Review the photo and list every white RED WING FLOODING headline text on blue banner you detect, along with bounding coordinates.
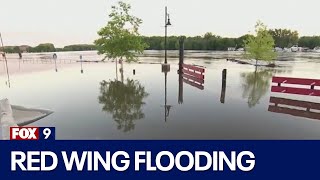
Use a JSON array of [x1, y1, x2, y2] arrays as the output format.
[[11, 151, 255, 172]]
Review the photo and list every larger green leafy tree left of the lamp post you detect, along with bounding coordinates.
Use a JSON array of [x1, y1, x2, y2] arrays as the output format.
[[94, 1, 147, 62]]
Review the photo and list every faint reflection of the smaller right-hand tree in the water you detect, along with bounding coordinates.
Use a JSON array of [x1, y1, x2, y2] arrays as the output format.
[[241, 69, 274, 108]]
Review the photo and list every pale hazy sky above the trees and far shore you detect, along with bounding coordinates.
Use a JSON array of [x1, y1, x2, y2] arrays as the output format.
[[0, 0, 320, 47]]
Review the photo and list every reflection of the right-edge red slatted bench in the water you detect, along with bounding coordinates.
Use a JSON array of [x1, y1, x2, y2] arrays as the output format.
[[268, 97, 320, 120]]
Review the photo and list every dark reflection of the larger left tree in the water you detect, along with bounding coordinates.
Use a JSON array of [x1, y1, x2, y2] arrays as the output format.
[[99, 79, 149, 132]]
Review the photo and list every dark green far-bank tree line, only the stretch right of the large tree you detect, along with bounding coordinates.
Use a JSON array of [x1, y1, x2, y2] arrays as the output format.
[[144, 29, 320, 51]]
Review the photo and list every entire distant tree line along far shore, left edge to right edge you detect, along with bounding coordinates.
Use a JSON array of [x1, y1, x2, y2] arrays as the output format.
[[0, 29, 320, 53]]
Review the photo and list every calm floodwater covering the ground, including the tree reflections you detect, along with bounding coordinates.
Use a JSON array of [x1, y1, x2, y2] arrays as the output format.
[[0, 51, 320, 140]]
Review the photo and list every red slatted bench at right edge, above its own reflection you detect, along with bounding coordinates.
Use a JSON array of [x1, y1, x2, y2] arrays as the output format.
[[271, 77, 320, 96]]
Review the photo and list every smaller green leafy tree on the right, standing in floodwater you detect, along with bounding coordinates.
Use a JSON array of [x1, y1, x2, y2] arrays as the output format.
[[245, 21, 277, 63]]
